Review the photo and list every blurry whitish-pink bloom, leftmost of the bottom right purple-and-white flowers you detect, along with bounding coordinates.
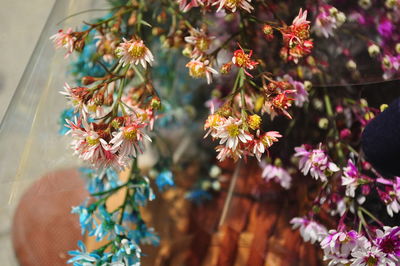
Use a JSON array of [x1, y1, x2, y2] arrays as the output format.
[[290, 217, 328, 244]]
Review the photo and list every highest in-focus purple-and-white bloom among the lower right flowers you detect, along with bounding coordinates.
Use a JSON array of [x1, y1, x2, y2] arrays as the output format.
[[294, 146, 340, 182]]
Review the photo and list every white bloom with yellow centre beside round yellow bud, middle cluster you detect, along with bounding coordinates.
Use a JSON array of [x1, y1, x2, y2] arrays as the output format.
[[212, 117, 253, 150]]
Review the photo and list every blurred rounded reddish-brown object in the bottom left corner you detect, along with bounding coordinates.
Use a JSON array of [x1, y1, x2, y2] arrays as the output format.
[[12, 169, 87, 266]]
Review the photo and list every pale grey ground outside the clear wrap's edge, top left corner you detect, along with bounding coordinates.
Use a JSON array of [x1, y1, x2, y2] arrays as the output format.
[[0, 0, 55, 121]]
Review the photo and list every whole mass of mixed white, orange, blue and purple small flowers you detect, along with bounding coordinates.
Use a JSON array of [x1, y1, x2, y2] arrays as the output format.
[[51, 0, 400, 265]]
